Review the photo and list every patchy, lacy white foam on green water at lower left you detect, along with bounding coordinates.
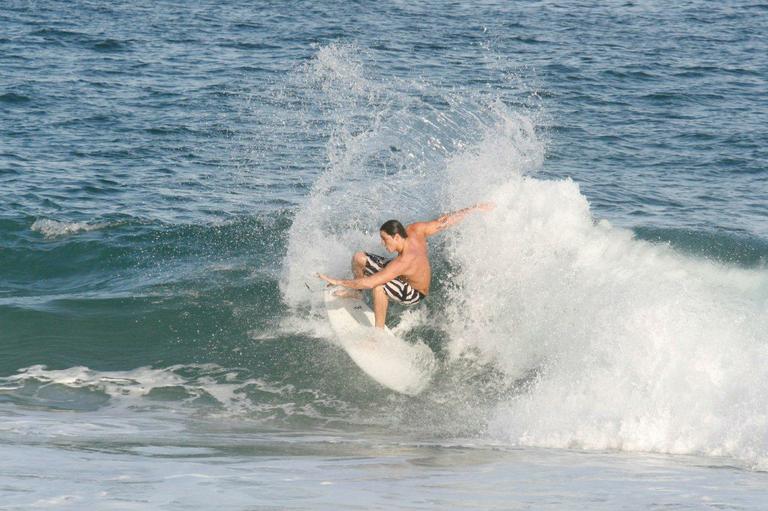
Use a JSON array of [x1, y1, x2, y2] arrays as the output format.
[[0, 364, 358, 437]]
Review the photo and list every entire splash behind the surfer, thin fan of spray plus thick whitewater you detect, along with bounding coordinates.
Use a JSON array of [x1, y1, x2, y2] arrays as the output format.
[[281, 46, 768, 466]]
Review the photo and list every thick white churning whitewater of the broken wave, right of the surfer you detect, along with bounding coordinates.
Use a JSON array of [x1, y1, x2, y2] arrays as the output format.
[[440, 124, 768, 465]]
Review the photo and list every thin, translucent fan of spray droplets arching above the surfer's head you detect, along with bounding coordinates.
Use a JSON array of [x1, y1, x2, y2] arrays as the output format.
[[281, 45, 544, 307]]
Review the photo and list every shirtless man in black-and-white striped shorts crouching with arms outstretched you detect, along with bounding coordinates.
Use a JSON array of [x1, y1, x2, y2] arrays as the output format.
[[317, 202, 496, 328]]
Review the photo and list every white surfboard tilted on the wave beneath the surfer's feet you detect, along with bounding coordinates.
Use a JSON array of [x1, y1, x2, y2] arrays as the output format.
[[325, 288, 436, 396]]
